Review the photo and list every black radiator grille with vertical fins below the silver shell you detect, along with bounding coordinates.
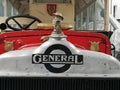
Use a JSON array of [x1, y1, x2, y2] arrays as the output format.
[[0, 77, 120, 90]]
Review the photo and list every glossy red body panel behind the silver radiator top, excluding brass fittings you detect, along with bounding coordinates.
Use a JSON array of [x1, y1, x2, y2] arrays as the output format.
[[0, 30, 111, 54]]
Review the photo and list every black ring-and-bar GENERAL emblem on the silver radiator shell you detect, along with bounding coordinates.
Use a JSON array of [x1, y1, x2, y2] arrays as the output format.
[[32, 44, 83, 73]]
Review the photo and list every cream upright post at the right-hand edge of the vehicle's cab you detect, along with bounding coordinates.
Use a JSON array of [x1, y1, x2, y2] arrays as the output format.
[[104, 0, 109, 31]]
